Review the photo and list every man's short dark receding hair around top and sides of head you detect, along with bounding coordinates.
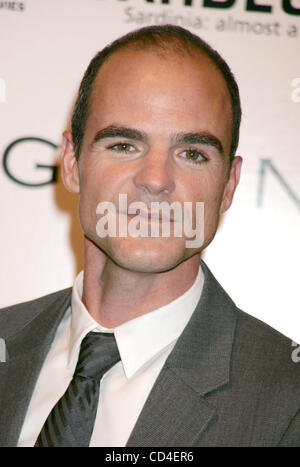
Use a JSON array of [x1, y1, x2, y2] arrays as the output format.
[[72, 24, 241, 165]]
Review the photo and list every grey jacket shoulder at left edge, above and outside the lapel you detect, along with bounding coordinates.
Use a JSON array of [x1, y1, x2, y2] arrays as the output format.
[[0, 287, 72, 337]]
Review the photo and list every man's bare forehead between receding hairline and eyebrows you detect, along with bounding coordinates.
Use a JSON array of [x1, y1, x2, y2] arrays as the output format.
[[86, 47, 232, 156]]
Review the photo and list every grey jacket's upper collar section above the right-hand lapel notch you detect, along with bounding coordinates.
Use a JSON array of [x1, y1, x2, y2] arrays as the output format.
[[166, 261, 237, 395]]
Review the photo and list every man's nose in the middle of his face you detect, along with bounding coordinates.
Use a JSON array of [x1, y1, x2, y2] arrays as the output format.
[[133, 150, 175, 197]]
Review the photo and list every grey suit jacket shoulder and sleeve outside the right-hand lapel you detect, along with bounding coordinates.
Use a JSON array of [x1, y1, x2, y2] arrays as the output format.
[[207, 300, 300, 446]]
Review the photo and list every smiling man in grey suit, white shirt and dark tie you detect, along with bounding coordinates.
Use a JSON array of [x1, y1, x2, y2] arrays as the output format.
[[0, 26, 300, 447]]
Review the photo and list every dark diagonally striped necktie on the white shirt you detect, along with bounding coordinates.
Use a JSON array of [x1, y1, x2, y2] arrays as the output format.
[[35, 332, 120, 447]]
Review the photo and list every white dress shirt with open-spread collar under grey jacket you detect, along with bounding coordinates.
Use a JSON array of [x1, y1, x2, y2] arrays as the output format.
[[18, 267, 203, 447]]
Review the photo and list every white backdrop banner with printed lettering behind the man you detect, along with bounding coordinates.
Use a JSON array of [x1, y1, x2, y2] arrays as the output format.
[[0, 0, 300, 342]]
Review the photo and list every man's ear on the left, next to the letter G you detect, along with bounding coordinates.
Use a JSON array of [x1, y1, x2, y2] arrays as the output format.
[[61, 131, 80, 193]]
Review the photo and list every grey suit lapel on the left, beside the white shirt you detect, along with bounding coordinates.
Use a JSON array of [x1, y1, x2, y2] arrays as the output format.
[[0, 290, 71, 446]]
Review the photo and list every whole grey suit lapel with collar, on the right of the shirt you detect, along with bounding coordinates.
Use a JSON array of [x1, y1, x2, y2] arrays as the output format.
[[127, 261, 237, 447]]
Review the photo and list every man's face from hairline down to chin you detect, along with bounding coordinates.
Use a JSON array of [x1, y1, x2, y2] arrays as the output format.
[[62, 48, 241, 272]]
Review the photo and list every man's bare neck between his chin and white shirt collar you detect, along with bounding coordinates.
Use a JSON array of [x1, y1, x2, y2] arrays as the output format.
[[82, 237, 200, 328]]
